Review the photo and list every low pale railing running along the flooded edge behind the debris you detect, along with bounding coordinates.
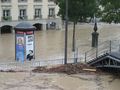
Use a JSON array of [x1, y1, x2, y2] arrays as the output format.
[[0, 58, 80, 71]]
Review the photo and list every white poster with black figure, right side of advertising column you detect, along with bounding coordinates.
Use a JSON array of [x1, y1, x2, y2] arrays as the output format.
[[26, 34, 34, 61]]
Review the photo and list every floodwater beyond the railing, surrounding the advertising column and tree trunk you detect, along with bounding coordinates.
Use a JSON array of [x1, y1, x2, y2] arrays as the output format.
[[0, 23, 120, 62]]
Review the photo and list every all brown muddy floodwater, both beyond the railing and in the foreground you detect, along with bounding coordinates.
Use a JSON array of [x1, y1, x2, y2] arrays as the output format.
[[0, 23, 120, 90]]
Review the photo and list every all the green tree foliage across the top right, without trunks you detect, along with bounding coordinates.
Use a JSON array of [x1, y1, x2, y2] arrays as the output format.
[[55, 0, 120, 23]]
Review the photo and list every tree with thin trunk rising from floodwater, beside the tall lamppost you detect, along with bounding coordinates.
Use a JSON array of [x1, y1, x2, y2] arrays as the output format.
[[55, 0, 98, 51]]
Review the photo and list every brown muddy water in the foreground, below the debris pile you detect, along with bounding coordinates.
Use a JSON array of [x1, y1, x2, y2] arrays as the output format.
[[0, 72, 120, 90]]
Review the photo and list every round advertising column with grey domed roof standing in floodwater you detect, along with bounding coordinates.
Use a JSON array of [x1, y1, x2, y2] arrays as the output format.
[[14, 22, 35, 62]]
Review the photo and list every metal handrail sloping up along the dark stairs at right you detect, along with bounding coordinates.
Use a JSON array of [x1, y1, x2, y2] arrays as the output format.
[[85, 40, 120, 62]]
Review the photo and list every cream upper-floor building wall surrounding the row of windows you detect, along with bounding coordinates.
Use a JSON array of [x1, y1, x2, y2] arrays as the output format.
[[0, 0, 59, 21]]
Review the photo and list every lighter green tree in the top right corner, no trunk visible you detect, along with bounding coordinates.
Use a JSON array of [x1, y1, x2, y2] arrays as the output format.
[[99, 0, 120, 23]]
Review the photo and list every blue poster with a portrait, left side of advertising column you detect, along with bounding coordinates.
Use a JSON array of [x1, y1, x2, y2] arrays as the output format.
[[16, 34, 24, 62]]
